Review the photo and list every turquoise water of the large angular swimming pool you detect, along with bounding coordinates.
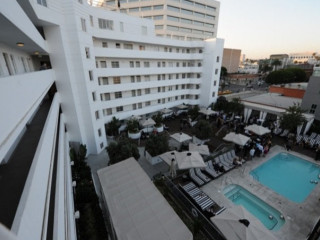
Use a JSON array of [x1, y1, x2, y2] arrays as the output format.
[[250, 153, 320, 203]]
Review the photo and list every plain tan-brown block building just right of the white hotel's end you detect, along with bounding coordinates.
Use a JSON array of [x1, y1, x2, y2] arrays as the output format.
[[222, 48, 241, 73]]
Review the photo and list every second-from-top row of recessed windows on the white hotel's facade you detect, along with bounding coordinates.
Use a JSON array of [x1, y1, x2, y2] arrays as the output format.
[[96, 60, 202, 68]]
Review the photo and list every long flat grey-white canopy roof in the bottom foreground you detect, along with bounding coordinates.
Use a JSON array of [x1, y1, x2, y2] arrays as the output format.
[[98, 158, 193, 240]]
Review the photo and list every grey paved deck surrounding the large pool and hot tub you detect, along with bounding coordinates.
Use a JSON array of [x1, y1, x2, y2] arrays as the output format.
[[201, 146, 320, 240]]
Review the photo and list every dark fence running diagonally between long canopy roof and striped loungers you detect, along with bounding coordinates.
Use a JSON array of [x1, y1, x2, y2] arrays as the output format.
[[164, 176, 226, 240]]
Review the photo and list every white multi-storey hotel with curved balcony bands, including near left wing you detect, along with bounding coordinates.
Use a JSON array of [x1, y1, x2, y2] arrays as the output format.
[[0, 0, 224, 236]]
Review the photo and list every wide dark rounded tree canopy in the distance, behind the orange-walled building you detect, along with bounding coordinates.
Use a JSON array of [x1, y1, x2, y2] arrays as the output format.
[[266, 68, 307, 84]]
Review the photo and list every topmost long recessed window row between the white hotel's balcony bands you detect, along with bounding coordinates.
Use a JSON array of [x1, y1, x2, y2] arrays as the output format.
[[96, 41, 202, 56]]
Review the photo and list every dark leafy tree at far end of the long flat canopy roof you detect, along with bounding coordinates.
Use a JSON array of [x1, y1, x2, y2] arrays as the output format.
[[107, 139, 140, 164]]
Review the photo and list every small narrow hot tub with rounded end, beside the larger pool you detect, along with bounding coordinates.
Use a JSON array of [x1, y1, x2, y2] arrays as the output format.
[[223, 184, 285, 231]]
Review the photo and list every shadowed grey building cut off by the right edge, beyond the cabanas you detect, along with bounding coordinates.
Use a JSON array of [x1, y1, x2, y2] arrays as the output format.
[[301, 67, 320, 120]]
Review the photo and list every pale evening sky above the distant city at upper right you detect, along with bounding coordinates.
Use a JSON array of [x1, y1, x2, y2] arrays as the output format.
[[217, 0, 320, 59]]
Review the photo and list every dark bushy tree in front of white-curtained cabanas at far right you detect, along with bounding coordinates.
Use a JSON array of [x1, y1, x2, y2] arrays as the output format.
[[280, 105, 306, 133]]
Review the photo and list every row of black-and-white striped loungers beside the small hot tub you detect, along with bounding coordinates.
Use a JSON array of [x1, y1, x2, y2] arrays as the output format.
[[180, 182, 221, 212]]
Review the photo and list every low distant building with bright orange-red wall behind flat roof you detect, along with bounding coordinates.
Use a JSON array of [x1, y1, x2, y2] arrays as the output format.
[[269, 82, 308, 99]]
